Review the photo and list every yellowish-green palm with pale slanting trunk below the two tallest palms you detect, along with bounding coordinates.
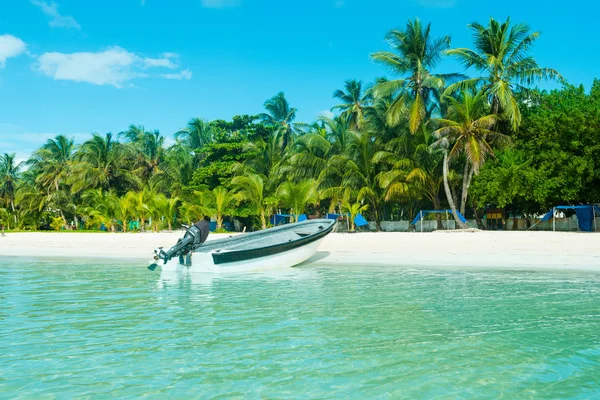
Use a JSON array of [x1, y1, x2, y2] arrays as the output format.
[[434, 91, 509, 222]]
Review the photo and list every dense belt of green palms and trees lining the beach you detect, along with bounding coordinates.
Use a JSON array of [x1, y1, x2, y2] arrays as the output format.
[[0, 18, 600, 232]]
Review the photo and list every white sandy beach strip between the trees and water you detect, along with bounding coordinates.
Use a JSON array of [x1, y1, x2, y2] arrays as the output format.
[[0, 232, 600, 272]]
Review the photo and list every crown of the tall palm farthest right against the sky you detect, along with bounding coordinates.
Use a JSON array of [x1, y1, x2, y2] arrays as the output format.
[[446, 17, 561, 130]]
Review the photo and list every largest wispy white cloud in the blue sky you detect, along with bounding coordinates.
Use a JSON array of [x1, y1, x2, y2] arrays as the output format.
[[35, 46, 192, 88]]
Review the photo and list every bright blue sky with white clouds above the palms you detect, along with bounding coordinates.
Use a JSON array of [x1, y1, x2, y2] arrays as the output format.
[[0, 0, 600, 160]]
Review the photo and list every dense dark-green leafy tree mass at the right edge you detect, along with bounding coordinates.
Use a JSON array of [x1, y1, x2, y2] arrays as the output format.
[[472, 81, 600, 212]]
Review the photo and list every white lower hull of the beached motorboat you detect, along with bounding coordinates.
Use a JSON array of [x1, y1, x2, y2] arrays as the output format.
[[161, 238, 323, 273]]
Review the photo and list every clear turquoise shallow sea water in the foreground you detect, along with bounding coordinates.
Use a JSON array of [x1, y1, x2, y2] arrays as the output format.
[[0, 259, 600, 399]]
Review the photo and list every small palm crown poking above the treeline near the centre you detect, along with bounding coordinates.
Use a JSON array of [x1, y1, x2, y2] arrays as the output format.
[[259, 92, 299, 153]]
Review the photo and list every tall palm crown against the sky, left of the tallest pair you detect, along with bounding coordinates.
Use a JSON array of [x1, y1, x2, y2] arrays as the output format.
[[371, 19, 462, 134]]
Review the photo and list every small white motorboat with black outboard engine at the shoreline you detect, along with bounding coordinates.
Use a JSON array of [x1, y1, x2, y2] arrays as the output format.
[[148, 219, 335, 272]]
